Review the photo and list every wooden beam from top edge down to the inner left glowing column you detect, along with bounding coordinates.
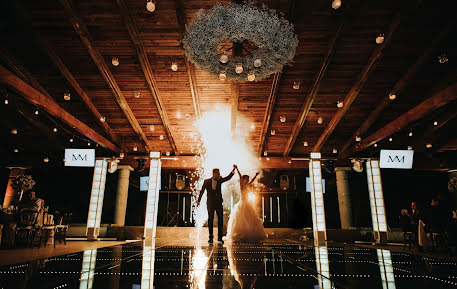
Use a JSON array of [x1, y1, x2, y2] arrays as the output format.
[[60, 0, 153, 150]]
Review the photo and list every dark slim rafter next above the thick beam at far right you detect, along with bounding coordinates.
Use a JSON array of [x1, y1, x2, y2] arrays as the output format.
[[340, 23, 455, 157]]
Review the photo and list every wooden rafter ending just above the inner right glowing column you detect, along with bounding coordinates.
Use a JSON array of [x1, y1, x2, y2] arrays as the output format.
[[313, 15, 400, 151]]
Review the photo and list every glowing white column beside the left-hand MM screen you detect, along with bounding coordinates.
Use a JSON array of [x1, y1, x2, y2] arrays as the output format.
[[86, 158, 108, 240]]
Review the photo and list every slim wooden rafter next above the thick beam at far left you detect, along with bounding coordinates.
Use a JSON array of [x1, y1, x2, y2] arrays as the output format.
[[35, 35, 120, 144]]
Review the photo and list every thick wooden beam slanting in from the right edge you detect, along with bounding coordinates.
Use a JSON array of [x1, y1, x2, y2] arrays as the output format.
[[351, 83, 457, 153]]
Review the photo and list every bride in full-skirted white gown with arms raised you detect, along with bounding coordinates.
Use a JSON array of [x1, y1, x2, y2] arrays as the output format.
[[227, 168, 265, 242]]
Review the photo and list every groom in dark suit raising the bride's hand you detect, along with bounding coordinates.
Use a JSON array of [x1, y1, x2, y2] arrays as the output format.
[[197, 165, 237, 243]]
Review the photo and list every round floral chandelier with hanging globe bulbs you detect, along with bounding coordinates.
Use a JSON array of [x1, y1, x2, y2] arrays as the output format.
[[183, 2, 298, 82]]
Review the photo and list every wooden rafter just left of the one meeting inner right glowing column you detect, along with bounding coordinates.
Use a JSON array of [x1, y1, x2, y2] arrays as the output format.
[[283, 21, 344, 156]]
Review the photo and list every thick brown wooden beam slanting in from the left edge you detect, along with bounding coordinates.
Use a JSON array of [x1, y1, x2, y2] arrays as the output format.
[[0, 66, 121, 153]]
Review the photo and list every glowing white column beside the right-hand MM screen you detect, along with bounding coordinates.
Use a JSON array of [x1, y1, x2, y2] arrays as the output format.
[[366, 159, 388, 243]]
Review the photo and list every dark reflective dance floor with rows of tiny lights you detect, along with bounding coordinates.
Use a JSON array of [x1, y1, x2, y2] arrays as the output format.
[[0, 241, 457, 289]]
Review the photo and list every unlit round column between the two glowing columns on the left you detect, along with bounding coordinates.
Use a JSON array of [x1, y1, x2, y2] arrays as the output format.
[[113, 165, 133, 227]]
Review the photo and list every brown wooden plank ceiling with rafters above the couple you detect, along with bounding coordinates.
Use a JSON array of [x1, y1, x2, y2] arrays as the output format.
[[0, 0, 457, 169]]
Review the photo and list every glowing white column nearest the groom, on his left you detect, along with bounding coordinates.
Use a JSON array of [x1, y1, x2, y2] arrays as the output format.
[[144, 152, 161, 238]]
